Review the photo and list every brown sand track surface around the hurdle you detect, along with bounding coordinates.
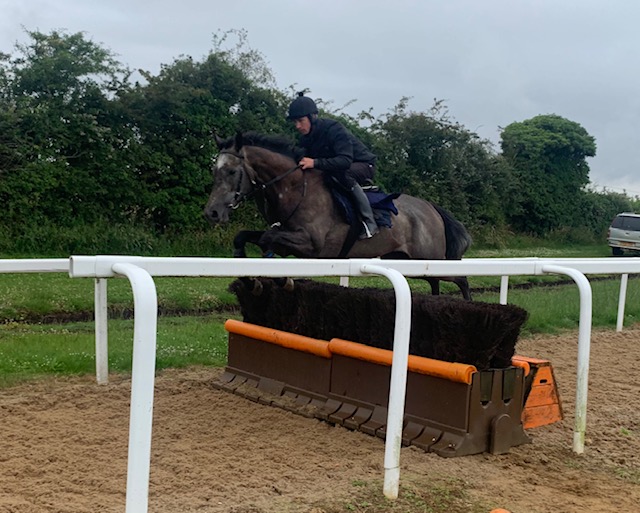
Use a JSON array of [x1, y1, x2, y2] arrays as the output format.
[[0, 326, 640, 513]]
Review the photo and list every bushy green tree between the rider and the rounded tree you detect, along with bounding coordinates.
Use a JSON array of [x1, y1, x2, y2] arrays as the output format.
[[372, 98, 509, 228]]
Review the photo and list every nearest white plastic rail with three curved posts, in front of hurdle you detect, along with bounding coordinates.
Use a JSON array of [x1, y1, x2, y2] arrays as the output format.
[[69, 256, 616, 513]]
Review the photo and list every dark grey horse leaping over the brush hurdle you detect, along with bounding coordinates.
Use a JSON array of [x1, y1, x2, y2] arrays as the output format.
[[204, 132, 471, 300]]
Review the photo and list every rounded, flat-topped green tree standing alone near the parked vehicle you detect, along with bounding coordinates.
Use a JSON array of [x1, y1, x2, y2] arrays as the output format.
[[501, 115, 596, 235]]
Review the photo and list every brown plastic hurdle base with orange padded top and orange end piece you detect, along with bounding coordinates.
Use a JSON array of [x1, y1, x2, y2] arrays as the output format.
[[216, 320, 562, 457]]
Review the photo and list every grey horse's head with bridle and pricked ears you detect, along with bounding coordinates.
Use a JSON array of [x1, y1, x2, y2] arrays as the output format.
[[204, 135, 252, 225]]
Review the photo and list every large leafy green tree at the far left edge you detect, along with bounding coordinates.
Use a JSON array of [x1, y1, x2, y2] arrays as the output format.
[[0, 31, 131, 226]]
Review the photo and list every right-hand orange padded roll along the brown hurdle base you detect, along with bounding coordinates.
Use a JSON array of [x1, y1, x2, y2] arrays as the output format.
[[329, 338, 477, 385]]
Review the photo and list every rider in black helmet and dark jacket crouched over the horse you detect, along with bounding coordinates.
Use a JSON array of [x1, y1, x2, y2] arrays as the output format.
[[287, 93, 378, 239]]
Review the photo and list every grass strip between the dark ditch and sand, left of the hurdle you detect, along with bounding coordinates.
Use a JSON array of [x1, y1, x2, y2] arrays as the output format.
[[0, 313, 235, 387]]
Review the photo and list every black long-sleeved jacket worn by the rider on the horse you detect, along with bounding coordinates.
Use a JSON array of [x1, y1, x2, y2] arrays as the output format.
[[299, 118, 376, 171]]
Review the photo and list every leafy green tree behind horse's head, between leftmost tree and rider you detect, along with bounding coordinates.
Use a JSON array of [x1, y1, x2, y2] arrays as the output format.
[[122, 45, 284, 230]]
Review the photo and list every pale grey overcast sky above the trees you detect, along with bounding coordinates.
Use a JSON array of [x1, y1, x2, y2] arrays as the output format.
[[5, 0, 640, 196]]
